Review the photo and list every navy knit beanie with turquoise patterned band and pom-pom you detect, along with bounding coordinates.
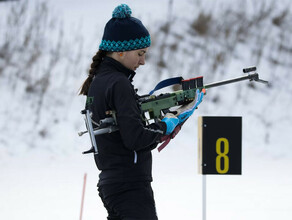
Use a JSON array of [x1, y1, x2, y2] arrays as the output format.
[[99, 4, 151, 52]]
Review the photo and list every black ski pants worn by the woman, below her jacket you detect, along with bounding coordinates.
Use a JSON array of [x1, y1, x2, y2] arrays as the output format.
[[98, 182, 158, 220]]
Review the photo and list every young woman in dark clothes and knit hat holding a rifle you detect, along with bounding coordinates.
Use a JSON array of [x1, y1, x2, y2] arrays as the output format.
[[80, 4, 203, 220]]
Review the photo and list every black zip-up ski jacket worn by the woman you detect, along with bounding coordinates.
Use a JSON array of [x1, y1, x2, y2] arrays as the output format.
[[88, 57, 166, 186]]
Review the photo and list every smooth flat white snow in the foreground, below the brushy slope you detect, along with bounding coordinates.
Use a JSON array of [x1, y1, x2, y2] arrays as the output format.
[[0, 131, 292, 220]]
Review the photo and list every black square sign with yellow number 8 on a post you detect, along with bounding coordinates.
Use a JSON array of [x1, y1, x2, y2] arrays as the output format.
[[198, 116, 242, 175]]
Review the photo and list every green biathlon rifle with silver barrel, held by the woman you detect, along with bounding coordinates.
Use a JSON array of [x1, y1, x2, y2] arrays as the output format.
[[78, 67, 268, 154]]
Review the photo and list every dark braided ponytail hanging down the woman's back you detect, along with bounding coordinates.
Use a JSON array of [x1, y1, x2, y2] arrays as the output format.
[[79, 50, 106, 96]]
